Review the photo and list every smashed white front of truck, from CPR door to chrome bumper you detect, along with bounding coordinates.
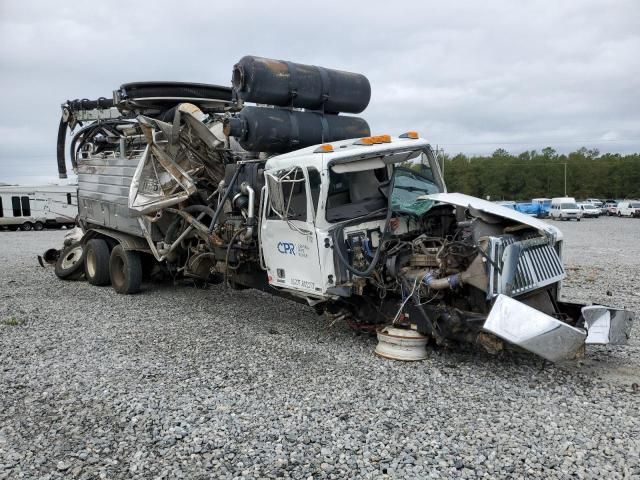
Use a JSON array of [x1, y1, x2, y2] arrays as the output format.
[[261, 134, 632, 361]]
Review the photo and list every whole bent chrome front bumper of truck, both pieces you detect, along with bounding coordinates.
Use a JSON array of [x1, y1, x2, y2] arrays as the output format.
[[483, 295, 635, 362]]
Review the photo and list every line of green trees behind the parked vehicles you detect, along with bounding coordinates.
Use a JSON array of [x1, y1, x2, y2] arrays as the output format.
[[438, 147, 640, 200]]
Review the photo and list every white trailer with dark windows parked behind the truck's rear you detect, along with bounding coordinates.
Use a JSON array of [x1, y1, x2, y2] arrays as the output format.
[[0, 185, 78, 230]]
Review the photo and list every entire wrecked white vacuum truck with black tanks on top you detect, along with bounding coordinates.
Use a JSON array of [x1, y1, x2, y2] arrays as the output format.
[[56, 57, 633, 361]]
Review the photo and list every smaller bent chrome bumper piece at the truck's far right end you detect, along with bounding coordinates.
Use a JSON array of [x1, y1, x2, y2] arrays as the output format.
[[582, 305, 634, 345]]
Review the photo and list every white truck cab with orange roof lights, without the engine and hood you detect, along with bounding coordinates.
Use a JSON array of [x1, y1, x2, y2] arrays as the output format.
[[260, 132, 446, 297]]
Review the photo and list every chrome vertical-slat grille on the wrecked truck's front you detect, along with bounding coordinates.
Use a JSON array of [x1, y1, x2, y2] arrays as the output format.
[[489, 235, 565, 297]]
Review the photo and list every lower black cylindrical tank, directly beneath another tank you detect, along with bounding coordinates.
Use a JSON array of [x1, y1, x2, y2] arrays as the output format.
[[225, 107, 371, 153]]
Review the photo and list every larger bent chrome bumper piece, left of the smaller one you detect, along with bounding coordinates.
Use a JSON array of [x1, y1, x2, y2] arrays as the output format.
[[483, 295, 587, 362]]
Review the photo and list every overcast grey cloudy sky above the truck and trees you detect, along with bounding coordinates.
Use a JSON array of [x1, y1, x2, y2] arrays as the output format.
[[0, 0, 640, 184]]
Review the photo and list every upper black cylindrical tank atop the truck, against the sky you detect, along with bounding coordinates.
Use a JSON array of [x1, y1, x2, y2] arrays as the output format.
[[231, 56, 371, 113]]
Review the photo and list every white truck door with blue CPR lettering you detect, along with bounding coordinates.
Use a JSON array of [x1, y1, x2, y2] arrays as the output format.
[[260, 167, 322, 295]]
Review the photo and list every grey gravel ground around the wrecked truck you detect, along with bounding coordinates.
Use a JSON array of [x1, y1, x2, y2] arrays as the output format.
[[0, 218, 640, 479]]
